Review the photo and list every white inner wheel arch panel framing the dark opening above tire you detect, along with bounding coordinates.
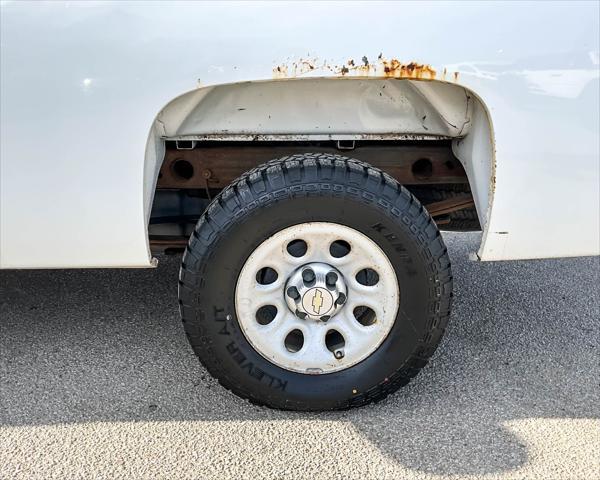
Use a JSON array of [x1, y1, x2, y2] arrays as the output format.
[[144, 75, 495, 262]]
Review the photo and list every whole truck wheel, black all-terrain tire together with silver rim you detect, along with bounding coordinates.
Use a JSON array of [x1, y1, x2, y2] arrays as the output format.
[[179, 154, 452, 410]]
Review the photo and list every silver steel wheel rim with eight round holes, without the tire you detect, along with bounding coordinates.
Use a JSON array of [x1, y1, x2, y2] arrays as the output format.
[[235, 222, 399, 374]]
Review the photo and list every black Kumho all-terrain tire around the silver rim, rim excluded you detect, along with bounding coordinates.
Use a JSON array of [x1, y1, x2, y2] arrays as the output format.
[[179, 154, 452, 410]]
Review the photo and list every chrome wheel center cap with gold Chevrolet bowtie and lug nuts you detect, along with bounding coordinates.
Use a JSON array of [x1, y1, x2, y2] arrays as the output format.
[[284, 262, 348, 322]]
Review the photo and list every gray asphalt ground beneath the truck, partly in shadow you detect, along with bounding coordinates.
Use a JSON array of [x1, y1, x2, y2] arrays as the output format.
[[0, 234, 600, 480]]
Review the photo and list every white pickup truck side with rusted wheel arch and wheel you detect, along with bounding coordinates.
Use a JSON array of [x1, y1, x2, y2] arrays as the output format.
[[0, 1, 600, 410]]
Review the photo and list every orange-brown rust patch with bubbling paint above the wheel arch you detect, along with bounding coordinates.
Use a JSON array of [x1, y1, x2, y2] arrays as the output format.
[[273, 54, 458, 81]]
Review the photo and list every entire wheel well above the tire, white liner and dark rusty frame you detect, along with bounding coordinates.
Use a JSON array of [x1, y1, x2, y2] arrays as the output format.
[[144, 78, 494, 255]]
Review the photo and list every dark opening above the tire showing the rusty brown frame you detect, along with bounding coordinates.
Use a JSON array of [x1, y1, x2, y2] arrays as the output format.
[[149, 140, 481, 253]]
